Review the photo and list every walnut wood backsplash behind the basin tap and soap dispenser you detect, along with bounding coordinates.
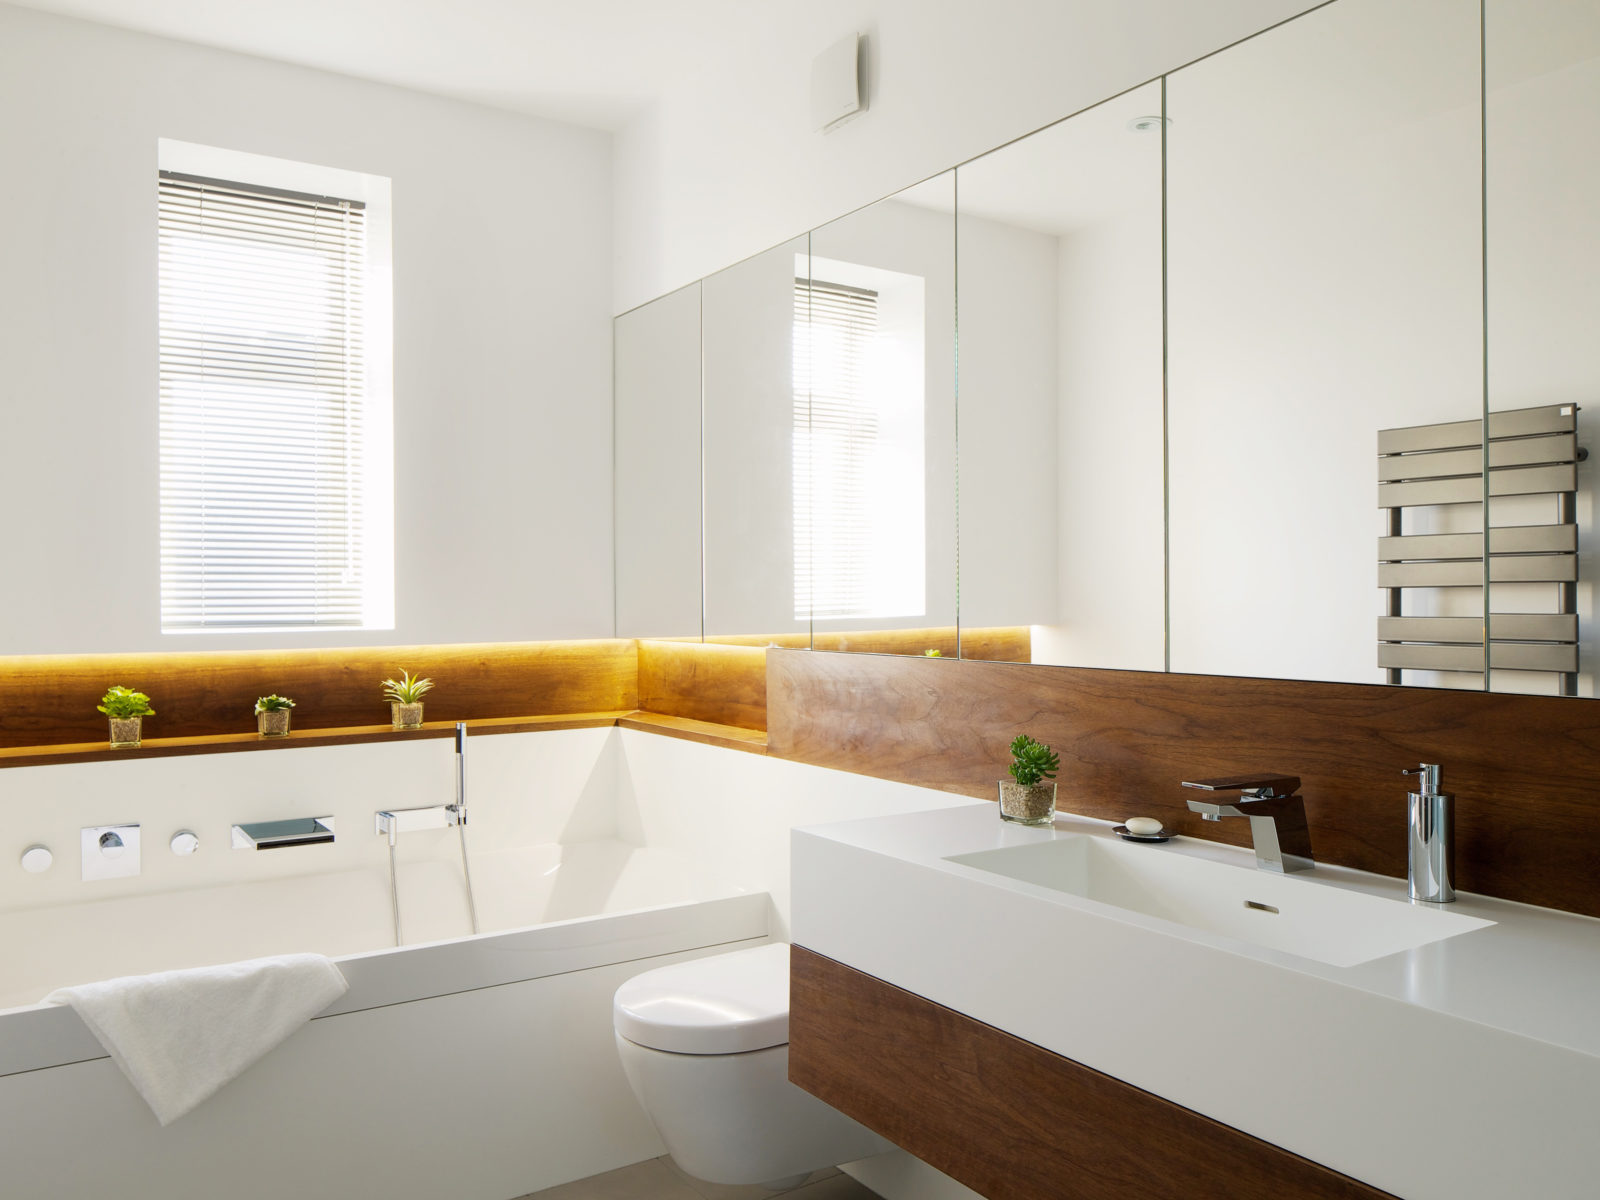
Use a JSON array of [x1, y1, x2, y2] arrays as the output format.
[[768, 650, 1600, 917]]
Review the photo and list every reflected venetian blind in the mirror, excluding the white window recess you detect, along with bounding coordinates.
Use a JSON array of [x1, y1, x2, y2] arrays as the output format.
[[794, 278, 878, 621]]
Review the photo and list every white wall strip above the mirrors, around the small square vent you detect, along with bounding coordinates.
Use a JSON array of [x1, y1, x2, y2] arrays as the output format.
[[614, 0, 1312, 312]]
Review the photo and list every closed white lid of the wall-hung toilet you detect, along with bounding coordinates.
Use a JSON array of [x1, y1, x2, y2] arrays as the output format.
[[611, 942, 789, 1054]]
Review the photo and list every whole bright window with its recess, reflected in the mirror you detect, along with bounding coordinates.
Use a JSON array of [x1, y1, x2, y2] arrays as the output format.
[[794, 256, 928, 621]]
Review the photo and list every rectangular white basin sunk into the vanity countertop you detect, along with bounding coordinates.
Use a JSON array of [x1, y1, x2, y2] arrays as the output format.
[[946, 834, 1494, 966]]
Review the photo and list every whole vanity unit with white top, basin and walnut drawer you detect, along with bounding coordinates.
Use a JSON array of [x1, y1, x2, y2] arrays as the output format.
[[790, 803, 1600, 1200]]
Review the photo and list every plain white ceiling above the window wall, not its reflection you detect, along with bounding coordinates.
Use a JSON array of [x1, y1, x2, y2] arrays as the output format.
[[11, 0, 773, 130]]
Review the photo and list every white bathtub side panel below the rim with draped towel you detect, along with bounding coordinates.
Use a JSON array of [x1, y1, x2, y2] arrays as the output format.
[[0, 954, 758, 1200]]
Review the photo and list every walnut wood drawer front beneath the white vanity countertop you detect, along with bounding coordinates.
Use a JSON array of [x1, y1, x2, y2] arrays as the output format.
[[789, 946, 1389, 1200]]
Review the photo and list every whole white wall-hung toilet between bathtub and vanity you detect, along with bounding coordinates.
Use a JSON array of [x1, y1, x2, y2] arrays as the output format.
[[611, 944, 894, 1184]]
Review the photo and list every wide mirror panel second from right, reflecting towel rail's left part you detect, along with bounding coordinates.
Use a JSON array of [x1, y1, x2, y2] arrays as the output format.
[[1166, 0, 1485, 688]]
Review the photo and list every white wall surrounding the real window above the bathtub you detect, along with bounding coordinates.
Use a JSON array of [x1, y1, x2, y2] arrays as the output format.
[[0, 5, 613, 654]]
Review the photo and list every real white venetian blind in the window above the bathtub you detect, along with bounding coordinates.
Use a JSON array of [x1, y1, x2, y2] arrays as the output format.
[[160, 171, 366, 632]]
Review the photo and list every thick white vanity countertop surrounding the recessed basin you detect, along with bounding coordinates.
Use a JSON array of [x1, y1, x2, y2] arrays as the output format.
[[794, 802, 1600, 1200]]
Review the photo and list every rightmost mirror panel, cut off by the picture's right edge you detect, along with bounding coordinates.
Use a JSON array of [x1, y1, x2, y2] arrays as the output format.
[[1485, 0, 1600, 696]]
